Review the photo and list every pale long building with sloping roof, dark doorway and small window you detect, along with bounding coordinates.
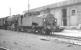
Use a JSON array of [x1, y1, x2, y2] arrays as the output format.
[[23, 0, 81, 27]]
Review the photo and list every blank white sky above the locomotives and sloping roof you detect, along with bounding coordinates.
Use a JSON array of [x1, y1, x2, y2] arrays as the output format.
[[0, 0, 64, 18]]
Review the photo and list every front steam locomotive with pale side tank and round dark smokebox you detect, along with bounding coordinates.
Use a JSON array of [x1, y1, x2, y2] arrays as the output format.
[[17, 13, 63, 34]]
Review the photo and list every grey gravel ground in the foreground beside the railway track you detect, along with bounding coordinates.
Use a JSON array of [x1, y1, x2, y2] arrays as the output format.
[[0, 30, 81, 50]]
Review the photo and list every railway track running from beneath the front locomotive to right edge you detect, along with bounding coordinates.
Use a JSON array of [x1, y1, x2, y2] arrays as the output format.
[[38, 34, 81, 46]]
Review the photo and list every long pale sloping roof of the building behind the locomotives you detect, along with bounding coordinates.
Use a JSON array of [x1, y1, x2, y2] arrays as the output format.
[[30, 0, 81, 11]]
